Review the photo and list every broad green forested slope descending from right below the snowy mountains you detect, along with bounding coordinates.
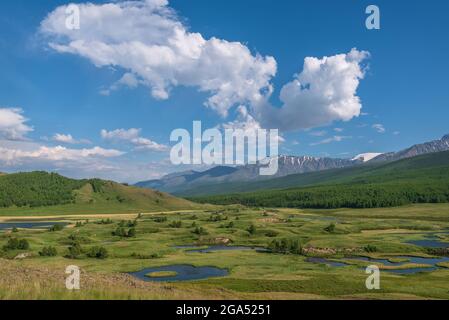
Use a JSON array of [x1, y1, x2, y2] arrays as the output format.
[[192, 152, 449, 208]]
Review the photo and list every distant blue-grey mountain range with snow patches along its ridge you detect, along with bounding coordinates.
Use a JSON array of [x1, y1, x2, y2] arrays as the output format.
[[136, 135, 449, 196]]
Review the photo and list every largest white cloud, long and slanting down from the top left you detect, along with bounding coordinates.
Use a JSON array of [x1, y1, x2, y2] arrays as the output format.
[[40, 0, 277, 116]]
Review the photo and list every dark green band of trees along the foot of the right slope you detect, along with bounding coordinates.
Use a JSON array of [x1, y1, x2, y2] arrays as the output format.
[[190, 182, 449, 209]]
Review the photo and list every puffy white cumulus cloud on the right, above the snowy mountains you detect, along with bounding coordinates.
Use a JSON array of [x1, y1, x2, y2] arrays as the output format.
[[255, 49, 369, 131]]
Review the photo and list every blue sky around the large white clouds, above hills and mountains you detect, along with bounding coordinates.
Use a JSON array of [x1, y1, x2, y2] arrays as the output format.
[[0, 0, 449, 182]]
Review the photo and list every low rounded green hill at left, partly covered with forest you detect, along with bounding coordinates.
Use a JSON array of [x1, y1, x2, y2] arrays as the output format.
[[0, 172, 198, 215]]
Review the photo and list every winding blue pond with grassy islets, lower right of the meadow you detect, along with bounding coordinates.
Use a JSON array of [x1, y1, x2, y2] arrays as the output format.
[[306, 256, 449, 274]]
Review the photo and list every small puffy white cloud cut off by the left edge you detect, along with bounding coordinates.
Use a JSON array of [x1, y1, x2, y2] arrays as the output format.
[[0, 108, 33, 140]]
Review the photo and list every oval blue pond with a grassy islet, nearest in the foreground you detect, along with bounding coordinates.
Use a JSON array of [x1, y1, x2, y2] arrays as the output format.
[[129, 265, 229, 282]]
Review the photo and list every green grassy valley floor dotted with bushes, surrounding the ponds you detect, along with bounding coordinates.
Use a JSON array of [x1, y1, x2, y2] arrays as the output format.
[[0, 204, 449, 299]]
